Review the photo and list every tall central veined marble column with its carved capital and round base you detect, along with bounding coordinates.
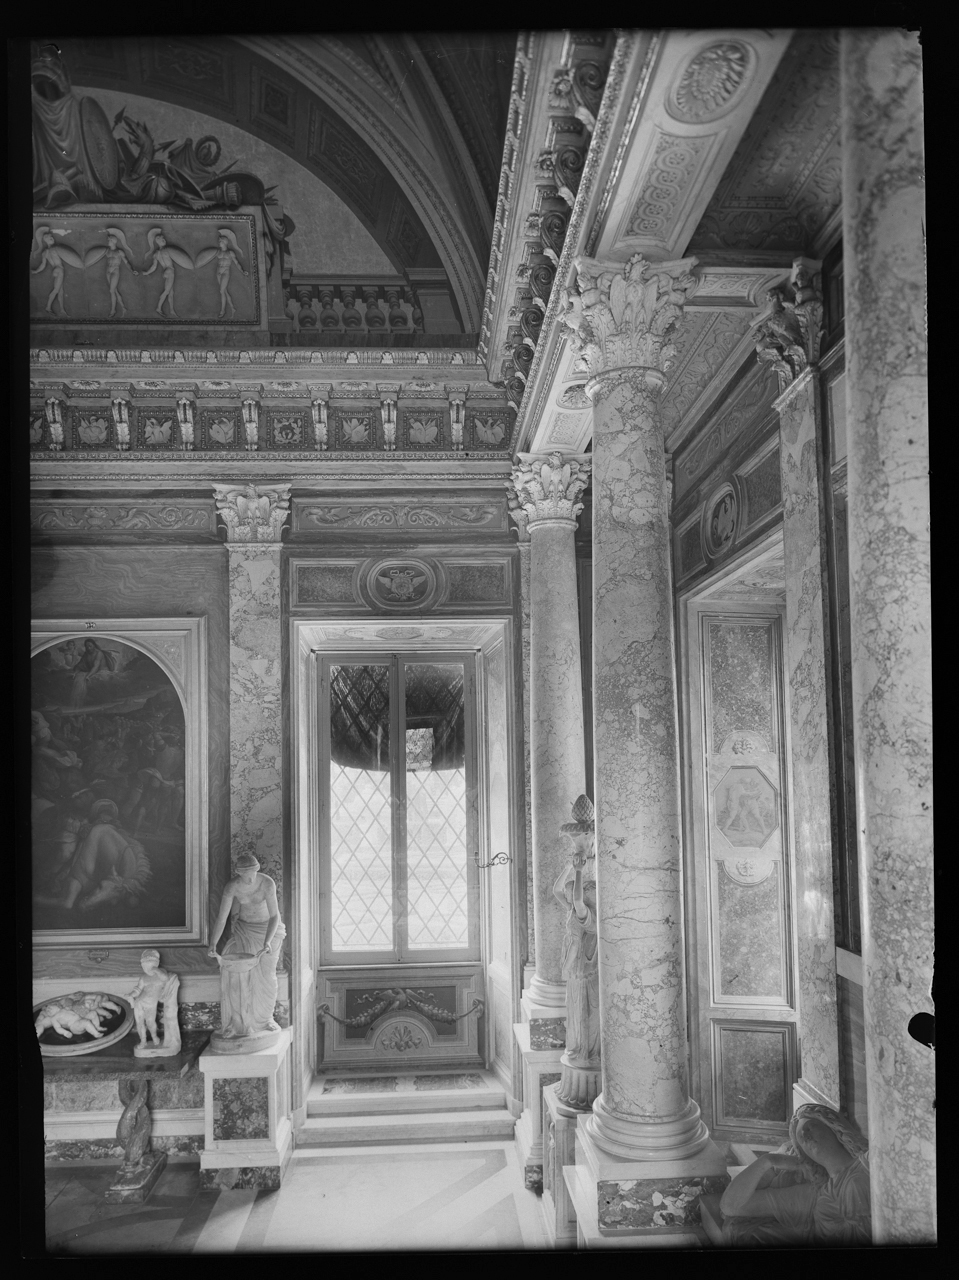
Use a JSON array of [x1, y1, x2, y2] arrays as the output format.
[[565, 255, 726, 1243]]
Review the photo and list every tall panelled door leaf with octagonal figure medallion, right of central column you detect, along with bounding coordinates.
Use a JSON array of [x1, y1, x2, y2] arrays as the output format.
[[684, 603, 798, 1143]]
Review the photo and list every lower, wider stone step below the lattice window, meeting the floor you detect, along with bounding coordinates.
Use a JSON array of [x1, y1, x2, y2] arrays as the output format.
[[296, 1108, 516, 1149]]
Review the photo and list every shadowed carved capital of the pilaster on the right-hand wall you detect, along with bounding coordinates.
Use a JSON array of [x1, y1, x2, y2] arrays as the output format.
[[753, 257, 822, 396]]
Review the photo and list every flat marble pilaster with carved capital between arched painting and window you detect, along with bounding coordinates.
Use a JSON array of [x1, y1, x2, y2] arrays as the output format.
[[214, 484, 289, 914]]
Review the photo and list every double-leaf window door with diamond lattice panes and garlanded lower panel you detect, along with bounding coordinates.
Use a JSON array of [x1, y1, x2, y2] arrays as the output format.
[[318, 653, 483, 1070]]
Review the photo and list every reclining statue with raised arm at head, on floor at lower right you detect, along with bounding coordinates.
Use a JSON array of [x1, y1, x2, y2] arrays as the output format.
[[720, 1103, 872, 1245]]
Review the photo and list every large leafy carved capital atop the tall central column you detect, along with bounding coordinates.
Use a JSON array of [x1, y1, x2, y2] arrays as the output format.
[[562, 253, 697, 376]]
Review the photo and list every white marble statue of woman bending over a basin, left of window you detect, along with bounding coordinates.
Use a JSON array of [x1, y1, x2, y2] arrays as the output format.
[[209, 854, 287, 1052]]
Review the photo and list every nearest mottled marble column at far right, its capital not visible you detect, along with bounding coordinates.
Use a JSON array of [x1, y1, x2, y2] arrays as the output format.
[[841, 29, 936, 1245]]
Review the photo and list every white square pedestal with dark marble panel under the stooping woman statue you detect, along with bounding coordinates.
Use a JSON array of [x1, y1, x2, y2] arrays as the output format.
[[200, 1028, 293, 1190]]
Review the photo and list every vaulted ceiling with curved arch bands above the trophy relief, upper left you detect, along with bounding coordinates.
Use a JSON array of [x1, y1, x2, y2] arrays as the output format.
[[46, 32, 516, 332]]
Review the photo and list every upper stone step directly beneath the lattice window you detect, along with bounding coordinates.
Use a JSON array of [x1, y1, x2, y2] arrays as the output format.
[[306, 1071, 506, 1116]]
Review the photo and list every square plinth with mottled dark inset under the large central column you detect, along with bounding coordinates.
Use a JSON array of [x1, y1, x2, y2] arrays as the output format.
[[565, 1116, 730, 1248]]
